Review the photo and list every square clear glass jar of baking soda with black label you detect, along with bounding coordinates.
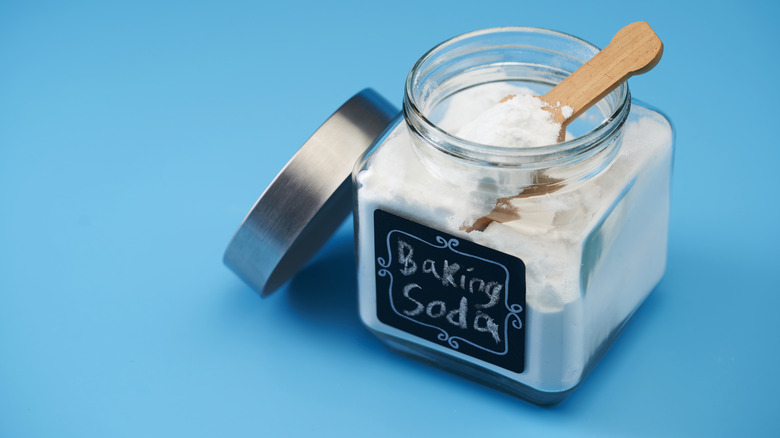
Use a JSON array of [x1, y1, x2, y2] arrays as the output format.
[[353, 27, 673, 404]]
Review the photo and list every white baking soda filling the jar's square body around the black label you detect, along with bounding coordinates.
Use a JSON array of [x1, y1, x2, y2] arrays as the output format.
[[356, 84, 671, 392]]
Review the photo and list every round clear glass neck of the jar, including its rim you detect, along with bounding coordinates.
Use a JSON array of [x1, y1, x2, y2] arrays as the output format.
[[403, 27, 630, 192]]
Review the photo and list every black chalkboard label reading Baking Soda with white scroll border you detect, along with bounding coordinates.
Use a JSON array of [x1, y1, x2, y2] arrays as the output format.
[[374, 210, 525, 373]]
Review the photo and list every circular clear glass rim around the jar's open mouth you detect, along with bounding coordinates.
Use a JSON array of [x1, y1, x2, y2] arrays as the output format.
[[403, 26, 631, 165]]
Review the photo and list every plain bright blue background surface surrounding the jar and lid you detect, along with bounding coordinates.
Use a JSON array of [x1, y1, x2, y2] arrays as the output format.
[[0, 0, 780, 437]]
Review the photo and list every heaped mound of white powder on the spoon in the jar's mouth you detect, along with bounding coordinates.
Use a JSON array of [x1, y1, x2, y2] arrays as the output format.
[[456, 94, 561, 147]]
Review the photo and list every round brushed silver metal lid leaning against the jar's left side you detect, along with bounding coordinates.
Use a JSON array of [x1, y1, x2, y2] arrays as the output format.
[[223, 89, 398, 296]]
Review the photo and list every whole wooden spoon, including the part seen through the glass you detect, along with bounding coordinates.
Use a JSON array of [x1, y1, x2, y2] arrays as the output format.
[[462, 21, 664, 232]]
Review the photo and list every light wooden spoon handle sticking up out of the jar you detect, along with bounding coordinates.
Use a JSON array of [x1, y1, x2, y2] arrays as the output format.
[[541, 21, 664, 128]]
